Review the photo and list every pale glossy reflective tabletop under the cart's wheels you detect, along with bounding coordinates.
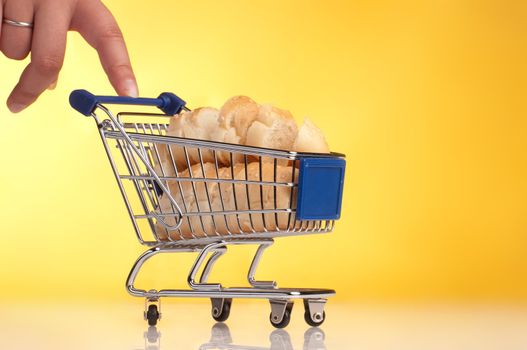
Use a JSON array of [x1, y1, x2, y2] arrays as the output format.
[[0, 299, 527, 350]]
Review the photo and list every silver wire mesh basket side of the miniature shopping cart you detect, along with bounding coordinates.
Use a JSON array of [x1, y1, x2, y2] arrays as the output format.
[[101, 119, 334, 243]]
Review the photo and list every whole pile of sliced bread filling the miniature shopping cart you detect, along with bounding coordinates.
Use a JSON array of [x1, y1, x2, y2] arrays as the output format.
[[154, 96, 329, 241]]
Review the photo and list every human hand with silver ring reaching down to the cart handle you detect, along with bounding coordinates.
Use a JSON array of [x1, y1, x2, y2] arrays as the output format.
[[0, 0, 138, 113]]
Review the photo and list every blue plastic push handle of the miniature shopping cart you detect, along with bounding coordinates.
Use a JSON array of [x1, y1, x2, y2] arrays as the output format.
[[70, 90, 186, 116]]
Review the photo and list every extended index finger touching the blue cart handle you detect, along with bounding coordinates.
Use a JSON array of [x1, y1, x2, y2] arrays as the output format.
[[72, 0, 138, 97]]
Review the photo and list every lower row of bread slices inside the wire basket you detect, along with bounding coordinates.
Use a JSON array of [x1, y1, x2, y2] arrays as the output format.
[[155, 162, 296, 240]]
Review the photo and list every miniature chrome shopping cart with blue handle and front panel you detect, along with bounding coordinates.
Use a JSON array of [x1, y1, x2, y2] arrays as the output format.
[[70, 90, 345, 328]]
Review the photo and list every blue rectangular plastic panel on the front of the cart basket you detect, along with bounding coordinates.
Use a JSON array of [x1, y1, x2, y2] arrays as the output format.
[[296, 157, 346, 220]]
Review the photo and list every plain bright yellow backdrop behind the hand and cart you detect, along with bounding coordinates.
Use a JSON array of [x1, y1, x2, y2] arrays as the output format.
[[0, 0, 527, 301]]
